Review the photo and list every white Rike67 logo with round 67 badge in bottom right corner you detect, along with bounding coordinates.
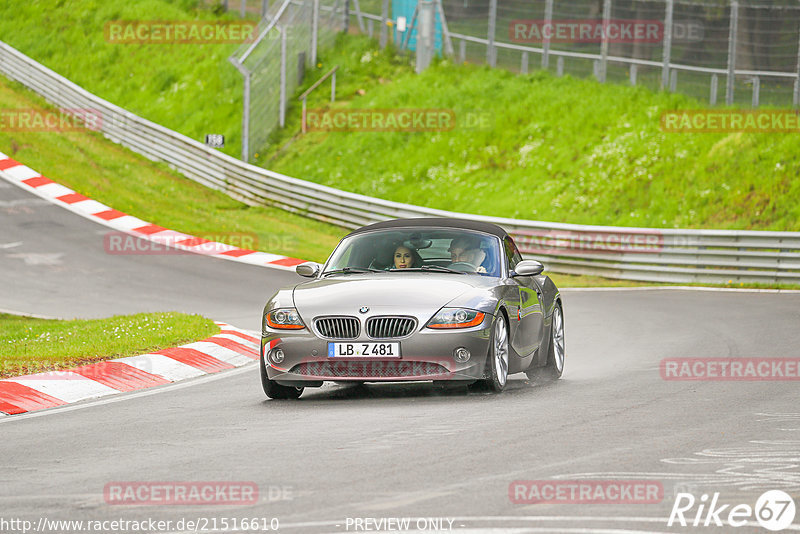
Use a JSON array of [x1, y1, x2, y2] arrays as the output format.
[[667, 490, 795, 531]]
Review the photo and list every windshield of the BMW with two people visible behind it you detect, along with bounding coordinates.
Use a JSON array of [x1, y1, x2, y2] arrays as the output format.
[[323, 227, 501, 276]]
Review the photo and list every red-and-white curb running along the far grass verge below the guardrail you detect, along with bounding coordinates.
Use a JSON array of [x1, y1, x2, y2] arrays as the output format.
[[0, 152, 305, 270]]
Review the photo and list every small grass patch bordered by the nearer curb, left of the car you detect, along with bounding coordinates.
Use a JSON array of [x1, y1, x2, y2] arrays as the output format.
[[0, 313, 219, 378]]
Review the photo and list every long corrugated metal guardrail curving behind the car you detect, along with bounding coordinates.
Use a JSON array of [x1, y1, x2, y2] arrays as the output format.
[[0, 38, 800, 284]]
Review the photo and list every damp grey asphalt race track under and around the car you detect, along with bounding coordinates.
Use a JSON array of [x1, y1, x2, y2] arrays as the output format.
[[0, 182, 800, 532]]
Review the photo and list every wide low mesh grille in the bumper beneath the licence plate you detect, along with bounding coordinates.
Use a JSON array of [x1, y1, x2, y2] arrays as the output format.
[[290, 360, 449, 379]]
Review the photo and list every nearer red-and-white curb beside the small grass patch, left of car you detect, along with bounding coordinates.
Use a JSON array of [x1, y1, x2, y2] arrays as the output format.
[[0, 322, 261, 416]]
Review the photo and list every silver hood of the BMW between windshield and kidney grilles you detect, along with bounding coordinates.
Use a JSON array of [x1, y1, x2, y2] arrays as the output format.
[[294, 273, 496, 321]]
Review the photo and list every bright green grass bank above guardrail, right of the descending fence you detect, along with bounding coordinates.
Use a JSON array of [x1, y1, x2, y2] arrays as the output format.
[[259, 36, 800, 230]]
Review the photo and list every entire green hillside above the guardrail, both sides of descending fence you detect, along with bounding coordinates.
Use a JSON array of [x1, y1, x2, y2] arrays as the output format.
[[0, 0, 800, 230]]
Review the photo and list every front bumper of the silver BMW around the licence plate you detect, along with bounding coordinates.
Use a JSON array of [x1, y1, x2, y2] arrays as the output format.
[[261, 320, 493, 385]]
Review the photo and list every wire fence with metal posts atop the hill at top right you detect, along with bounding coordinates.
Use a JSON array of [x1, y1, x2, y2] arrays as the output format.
[[352, 0, 800, 107]]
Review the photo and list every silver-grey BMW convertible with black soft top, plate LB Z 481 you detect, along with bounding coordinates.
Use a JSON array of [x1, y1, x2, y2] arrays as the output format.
[[261, 218, 565, 399]]
